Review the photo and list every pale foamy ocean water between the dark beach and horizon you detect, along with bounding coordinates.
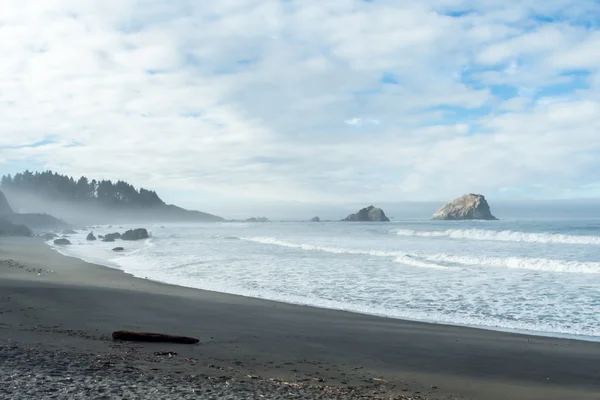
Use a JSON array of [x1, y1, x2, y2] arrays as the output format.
[[49, 219, 600, 340]]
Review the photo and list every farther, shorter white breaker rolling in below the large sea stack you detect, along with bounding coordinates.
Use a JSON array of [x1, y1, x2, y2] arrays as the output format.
[[394, 229, 600, 245]]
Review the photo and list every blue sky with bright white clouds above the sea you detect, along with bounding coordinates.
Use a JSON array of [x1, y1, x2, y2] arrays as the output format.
[[0, 0, 600, 215]]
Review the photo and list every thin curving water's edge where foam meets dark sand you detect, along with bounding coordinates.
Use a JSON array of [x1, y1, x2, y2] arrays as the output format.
[[43, 236, 600, 343]]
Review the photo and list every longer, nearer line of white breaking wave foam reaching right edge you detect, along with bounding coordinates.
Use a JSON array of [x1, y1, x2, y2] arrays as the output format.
[[240, 236, 600, 274]]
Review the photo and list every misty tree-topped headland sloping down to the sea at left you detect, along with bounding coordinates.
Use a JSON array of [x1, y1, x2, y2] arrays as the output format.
[[1, 171, 224, 224]]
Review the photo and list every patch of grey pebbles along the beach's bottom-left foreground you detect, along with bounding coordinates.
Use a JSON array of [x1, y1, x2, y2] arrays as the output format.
[[0, 345, 421, 400]]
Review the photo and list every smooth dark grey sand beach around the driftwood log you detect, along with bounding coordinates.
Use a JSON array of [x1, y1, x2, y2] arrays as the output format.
[[0, 238, 600, 400]]
